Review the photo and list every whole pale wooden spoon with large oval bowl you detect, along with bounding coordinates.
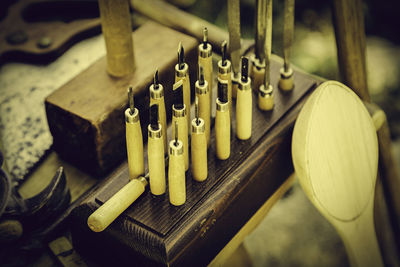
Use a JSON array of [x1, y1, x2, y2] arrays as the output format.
[[292, 81, 383, 266]]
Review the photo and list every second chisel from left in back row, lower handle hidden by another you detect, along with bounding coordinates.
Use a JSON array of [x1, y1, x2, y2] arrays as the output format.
[[149, 70, 168, 153]]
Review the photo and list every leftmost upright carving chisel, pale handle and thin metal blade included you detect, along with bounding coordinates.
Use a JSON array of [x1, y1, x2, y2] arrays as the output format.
[[125, 87, 144, 180]]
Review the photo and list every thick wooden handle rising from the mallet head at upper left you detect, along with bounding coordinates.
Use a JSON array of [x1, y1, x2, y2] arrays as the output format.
[[99, 0, 135, 77]]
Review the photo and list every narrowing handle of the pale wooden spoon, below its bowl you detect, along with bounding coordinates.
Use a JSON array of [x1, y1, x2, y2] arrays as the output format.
[[331, 197, 383, 267]]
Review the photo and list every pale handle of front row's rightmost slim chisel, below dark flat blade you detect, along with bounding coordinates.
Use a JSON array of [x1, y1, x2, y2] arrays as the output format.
[[236, 89, 253, 140]]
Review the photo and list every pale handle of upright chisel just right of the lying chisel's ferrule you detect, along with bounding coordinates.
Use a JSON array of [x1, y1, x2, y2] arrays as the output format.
[[147, 129, 166, 195]]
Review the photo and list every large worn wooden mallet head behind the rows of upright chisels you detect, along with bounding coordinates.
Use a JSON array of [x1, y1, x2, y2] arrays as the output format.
[[45, 22, 198, 176]]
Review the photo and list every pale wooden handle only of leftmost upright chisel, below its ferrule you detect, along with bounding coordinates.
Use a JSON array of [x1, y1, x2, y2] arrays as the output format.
[[125, 117, 144, 180]]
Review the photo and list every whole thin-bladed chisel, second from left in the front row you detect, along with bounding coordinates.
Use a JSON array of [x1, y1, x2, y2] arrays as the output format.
[[191, 96, 208, 182]]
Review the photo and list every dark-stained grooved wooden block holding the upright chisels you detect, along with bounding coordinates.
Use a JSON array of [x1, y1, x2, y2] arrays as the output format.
[[71, 59, 318, 266]]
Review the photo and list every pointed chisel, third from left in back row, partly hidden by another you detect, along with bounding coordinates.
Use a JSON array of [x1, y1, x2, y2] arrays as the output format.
[[175, 43, 190, 134]]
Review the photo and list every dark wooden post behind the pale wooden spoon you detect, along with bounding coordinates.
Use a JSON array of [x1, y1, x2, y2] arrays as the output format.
[[333, 0, 400, 254]]
